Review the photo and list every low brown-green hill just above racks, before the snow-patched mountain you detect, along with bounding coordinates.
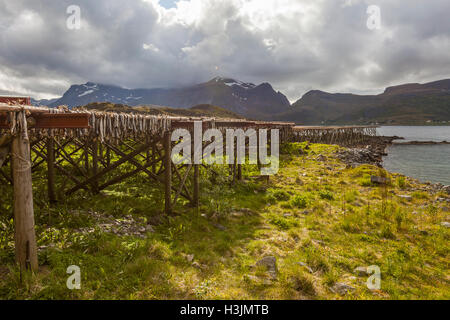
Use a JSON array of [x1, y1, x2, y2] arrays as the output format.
[[76, 102, 242, 119]]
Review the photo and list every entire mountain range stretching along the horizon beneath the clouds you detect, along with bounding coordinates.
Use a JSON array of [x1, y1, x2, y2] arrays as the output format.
[[33, 77, 450, 124]]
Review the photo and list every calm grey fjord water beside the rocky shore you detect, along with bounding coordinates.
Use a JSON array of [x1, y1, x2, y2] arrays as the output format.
[[377, 126, 450, 185]]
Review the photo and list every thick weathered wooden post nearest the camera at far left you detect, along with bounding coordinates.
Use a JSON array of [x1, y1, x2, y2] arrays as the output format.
[[11, 113, 38, 271]]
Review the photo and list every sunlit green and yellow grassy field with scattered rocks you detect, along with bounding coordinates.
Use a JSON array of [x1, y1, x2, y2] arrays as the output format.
[[0, 144, 450, 299]]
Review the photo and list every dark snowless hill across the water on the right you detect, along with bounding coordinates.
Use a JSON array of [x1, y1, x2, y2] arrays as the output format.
[[274, 79, 450, 124]]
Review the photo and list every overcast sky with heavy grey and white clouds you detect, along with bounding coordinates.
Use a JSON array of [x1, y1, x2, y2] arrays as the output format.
[[0, 0, 450, 101]]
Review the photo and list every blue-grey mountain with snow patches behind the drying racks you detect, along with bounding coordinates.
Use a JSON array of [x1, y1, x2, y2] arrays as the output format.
[[40, 77, 290, 118]]
